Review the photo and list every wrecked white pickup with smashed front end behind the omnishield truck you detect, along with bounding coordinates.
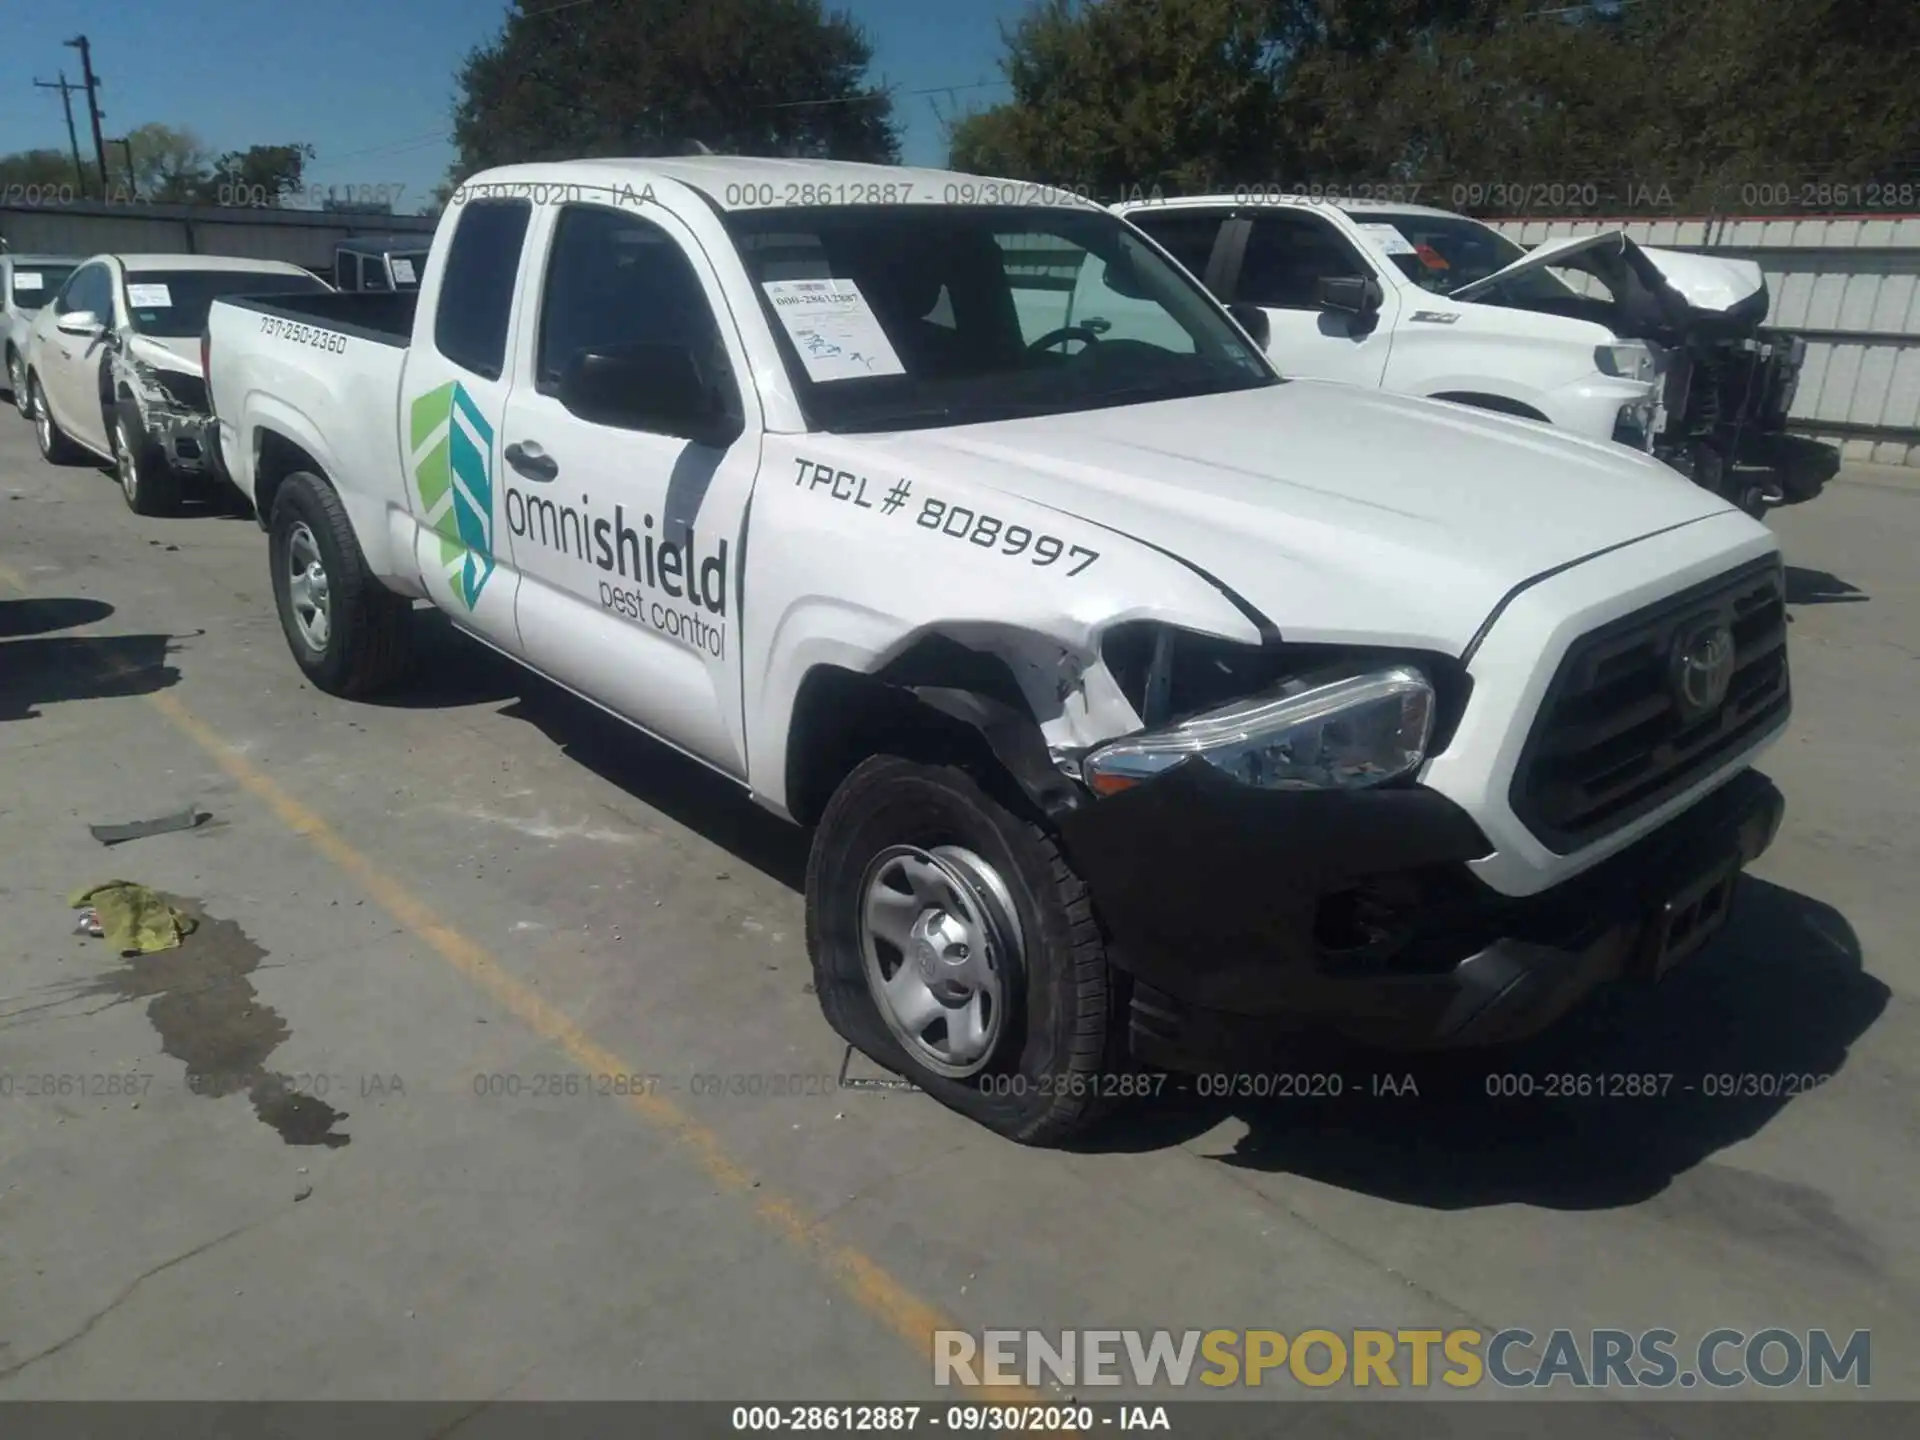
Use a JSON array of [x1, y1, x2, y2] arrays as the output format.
[[1116, 190, 1839, 515]]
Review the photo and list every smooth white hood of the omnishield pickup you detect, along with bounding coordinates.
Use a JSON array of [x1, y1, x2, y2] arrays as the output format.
[[854, 380, 1730, 655]]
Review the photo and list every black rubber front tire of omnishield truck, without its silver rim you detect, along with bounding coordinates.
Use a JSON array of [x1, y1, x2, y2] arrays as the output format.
[[806, 755, 1117, 1144]]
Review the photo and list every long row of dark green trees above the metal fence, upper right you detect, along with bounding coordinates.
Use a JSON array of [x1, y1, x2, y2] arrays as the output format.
[[950, 0, 1920, 211]]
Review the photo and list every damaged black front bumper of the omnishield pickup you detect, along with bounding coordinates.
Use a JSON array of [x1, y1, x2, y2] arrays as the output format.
[[1062, 760, 1784, 1069]]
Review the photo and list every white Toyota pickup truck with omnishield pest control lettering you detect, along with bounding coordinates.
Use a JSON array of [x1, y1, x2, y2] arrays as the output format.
[[207, 157, 1789, 1142]]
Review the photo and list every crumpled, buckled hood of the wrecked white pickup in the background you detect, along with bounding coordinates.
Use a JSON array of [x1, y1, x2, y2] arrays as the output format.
[[1452, 230, 1766, 340]]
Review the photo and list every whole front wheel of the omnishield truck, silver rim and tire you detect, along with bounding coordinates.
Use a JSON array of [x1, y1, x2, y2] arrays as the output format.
[[806, 755, 1114, 1144]]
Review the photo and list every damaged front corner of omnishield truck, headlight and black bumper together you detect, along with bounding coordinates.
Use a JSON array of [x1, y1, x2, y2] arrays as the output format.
[[1054, 626, 1782, 1071]]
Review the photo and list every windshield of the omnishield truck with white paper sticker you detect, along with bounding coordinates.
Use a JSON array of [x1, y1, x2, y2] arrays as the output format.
[[728, 205, 1279, 432]]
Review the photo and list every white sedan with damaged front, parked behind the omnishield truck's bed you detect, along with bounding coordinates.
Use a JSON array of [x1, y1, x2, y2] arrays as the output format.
[[23, 255, 330, 515]]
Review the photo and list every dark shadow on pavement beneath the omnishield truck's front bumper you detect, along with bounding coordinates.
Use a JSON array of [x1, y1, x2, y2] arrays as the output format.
[[1087, 876, 1889, 1210]]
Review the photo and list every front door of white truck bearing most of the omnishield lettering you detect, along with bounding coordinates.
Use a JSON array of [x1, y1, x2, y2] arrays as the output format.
[[503, 188, 762, 778]]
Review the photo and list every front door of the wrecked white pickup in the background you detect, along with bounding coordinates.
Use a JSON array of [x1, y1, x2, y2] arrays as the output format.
[[1221, 207, 1400, 388]]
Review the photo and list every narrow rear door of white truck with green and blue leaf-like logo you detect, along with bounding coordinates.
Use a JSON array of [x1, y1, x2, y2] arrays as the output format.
[[399, 200, 534, 653]]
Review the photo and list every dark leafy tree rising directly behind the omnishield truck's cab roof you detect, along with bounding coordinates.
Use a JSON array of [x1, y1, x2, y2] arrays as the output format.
[[449, 0, 899, 192]]
